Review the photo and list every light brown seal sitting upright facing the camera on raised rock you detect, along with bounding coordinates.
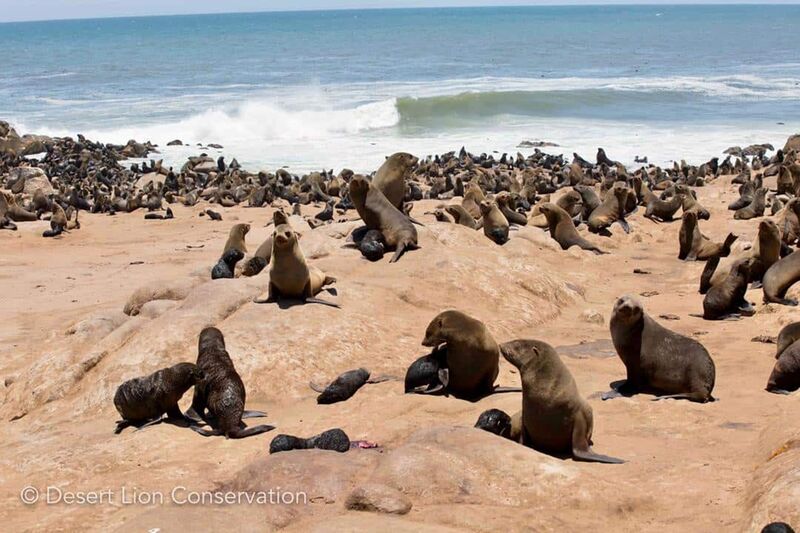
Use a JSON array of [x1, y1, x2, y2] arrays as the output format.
[[254, 224, 341, 308]]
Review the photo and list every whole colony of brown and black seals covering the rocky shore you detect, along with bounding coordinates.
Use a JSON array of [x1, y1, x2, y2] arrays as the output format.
[[0, 119, 800, 528]]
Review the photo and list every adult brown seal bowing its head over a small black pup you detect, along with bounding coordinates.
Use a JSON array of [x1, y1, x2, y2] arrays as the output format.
[[422, 310, 520, 400]]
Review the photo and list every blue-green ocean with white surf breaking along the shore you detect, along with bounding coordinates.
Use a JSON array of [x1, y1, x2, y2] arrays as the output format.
[[0, 5, 800, 172]]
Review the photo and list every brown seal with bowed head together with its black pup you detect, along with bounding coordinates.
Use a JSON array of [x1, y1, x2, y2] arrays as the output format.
[[406, 310, 521, 401]]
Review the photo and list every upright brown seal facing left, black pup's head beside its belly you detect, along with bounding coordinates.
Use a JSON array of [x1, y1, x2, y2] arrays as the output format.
[[500, 340, 624, 464]]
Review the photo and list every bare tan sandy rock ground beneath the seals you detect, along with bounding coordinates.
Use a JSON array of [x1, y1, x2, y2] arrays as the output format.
[[0, 177, 800, 532]]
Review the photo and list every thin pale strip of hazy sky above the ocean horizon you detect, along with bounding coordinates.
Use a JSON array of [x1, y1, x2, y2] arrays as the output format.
[[0, 0, 800, 22]]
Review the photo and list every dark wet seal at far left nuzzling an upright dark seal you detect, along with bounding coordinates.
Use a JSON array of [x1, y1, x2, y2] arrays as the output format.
[[114, 363, 205, 433]]
